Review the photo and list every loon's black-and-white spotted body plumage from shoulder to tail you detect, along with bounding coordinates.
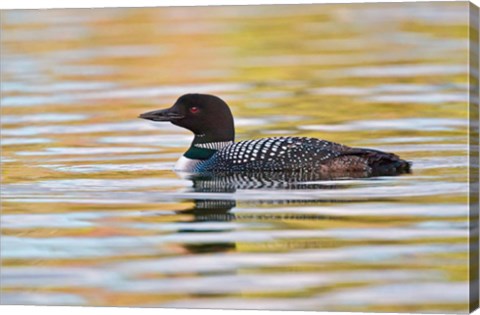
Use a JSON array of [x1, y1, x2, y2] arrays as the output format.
[[193, 137, 405, 173]]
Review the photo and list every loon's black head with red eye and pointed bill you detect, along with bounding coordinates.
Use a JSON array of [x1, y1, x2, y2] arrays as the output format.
[[140, 94, 235, 142]]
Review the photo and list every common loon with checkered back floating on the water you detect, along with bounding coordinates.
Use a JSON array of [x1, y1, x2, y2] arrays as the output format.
[[139, 94, 410, 177]]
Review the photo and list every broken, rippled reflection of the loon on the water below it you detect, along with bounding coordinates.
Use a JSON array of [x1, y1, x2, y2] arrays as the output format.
[[178, 172, 376, 253]]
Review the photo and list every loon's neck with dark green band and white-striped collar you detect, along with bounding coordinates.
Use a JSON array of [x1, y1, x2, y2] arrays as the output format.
[[183, 134, 234, 160]]
